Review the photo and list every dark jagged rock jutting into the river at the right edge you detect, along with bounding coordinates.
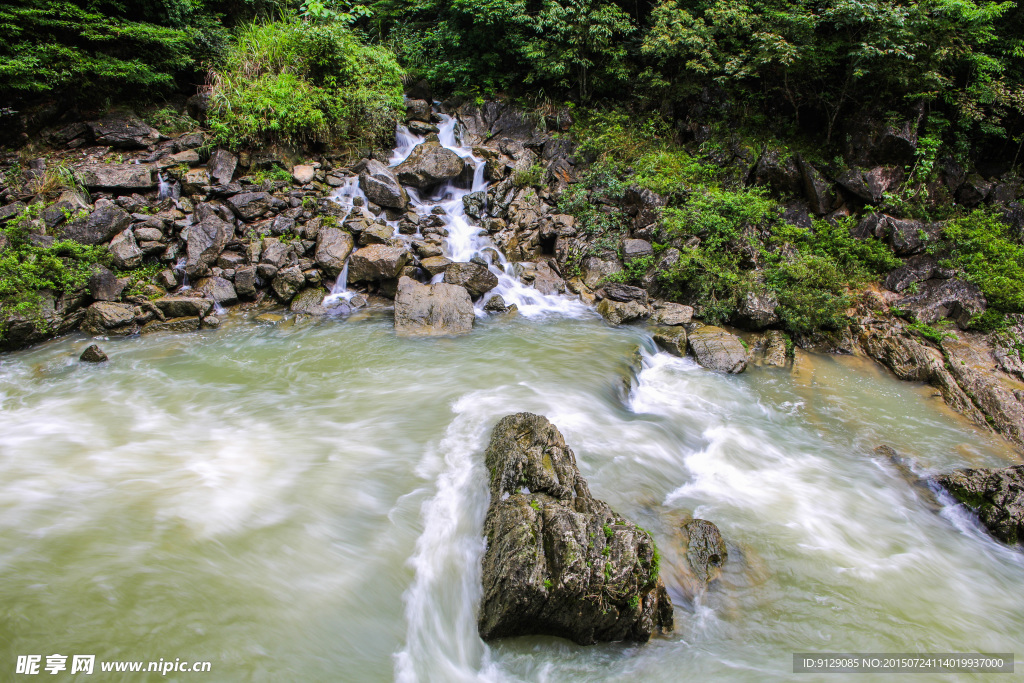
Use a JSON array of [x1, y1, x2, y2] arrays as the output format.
[[935, 465, 1024, 545]]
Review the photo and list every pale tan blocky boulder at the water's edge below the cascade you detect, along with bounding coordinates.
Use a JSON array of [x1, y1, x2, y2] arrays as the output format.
[[394, 278, 475, 337]]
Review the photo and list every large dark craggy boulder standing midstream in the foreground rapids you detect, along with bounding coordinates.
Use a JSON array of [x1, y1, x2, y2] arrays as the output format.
[[477, 413, 673, 645]]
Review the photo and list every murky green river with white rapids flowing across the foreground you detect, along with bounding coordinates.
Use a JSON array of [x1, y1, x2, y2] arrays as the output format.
[[0, 313, 1024, 682]]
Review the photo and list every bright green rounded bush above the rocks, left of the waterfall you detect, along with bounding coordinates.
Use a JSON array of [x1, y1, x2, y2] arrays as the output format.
[[210, 19, 402, 147]]
